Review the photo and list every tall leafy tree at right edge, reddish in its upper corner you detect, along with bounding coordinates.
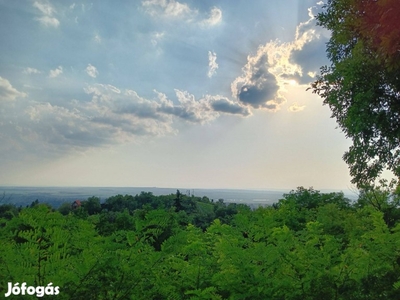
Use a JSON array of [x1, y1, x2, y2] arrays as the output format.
[[312, 0, 400, 187]]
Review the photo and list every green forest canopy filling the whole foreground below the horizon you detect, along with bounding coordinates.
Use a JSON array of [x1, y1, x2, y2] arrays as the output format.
[[0, 186, 400, 300]]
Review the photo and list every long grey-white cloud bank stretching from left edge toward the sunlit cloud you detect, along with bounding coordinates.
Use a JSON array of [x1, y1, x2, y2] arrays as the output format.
[[0, 78, 250, 155]]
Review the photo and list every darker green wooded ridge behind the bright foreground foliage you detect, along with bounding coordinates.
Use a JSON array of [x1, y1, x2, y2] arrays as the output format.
[[0, 190, 250, 229]]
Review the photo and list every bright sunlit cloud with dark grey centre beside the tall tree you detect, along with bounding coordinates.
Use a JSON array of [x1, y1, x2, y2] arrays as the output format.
[[231, 3, 328, 111]]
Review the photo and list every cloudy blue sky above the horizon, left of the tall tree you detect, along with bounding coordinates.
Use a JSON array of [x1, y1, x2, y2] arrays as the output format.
[[0, 0, 352, 190]]
